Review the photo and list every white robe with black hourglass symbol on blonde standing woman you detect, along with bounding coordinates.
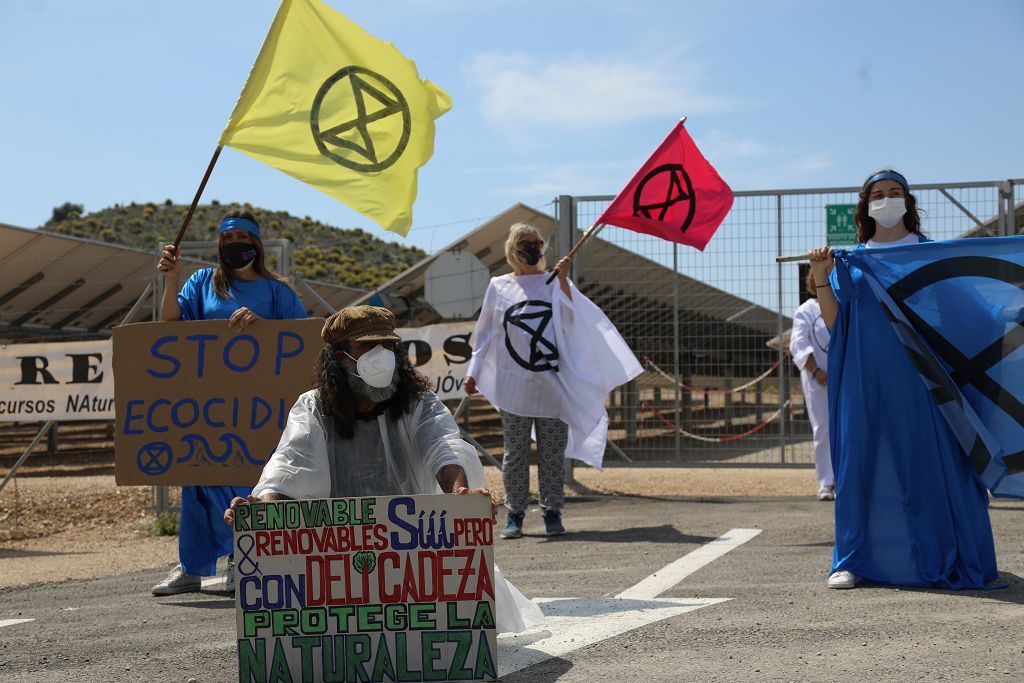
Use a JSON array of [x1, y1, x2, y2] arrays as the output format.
[[466, 272, 643, 469]]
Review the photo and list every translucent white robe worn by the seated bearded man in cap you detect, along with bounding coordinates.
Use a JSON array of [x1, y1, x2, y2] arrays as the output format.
[[253, 390, 544, 633]]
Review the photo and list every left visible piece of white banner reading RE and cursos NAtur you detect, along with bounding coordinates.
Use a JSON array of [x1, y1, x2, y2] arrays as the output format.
[[0, 339, 114, 422]]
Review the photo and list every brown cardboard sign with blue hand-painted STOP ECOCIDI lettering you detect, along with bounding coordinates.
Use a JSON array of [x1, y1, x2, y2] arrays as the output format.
[[114, 318, 324, 486]]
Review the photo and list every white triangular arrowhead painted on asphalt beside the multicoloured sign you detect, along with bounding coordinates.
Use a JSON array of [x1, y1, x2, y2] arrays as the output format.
[[498, 598, 730, 676]]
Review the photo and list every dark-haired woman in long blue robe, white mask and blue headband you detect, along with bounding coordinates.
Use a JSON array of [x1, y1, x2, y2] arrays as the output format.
[[810, 170, 997, 589]]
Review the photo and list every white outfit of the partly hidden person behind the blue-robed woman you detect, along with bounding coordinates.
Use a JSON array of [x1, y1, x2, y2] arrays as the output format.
[[790, 298, 836, 486]]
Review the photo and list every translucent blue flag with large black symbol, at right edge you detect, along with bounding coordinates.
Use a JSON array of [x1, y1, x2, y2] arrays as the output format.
[[835, 237, 1024, 499]]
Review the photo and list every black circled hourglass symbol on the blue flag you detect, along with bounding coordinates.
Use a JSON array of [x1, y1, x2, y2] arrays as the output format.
[[887, 256, 1024, 474]]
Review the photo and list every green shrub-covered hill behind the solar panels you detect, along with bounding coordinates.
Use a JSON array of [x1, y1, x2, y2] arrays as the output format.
[[41, 200, 426, 288]]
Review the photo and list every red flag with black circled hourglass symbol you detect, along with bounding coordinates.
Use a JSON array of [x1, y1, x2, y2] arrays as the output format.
[[596, 121, 732, 251]]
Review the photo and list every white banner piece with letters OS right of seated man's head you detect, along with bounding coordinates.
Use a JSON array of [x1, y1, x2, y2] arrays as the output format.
[[395, 323, 476, 400]]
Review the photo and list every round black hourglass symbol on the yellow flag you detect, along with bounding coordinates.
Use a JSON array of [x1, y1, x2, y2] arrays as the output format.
[[309, 67, 412, 173]]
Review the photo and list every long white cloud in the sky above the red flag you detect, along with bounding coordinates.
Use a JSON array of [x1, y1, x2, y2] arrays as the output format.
[[465, 52, 738, 135]]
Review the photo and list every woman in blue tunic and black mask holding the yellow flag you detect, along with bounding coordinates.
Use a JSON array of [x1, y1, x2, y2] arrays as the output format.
[[153, 211, 306, 595]]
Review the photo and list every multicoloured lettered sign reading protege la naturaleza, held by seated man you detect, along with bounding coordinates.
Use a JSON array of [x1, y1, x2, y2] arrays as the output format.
[[234, 495, 498, 683]]
